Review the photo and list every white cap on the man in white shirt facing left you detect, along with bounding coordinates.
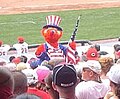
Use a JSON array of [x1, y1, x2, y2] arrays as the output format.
[[83, 60, 101, 74]]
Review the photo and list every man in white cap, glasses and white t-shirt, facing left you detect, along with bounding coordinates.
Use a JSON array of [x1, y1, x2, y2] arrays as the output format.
[[75, 60, 109, 99]]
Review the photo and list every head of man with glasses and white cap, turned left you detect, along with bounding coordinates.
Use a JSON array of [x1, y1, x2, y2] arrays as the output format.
[[82, 60, 101, 82]]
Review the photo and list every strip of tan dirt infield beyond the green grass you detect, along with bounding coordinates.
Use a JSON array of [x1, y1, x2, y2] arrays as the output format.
[[0, 0, 120, 14]]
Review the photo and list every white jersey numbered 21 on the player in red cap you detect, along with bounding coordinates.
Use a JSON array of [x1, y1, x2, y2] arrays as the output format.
[[13, 42, 28, 56]]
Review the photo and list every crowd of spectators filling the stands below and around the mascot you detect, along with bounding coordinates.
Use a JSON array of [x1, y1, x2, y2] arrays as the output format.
[[0, 37, 120, 99]]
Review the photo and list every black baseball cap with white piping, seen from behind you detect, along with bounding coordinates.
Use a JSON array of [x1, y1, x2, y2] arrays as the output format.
[[52, 64, 77, 88]]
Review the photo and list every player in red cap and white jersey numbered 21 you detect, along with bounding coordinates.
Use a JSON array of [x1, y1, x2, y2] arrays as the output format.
[[13, 36, 28, 56]]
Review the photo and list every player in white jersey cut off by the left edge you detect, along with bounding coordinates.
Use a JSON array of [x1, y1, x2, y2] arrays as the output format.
[[0, 40, 10, 60]]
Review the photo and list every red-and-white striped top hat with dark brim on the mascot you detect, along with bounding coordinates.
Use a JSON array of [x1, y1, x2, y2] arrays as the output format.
[[43, 15, 62, 31]]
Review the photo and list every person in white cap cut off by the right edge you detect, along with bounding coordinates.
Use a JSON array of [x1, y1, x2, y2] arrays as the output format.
[[104, 64, 120, 99]]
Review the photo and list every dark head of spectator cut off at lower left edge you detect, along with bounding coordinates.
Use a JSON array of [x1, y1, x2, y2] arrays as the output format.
[[0, 67, 14, 99]]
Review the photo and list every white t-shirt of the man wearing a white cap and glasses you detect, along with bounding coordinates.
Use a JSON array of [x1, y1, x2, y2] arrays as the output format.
[[75, 81, 109, 99]]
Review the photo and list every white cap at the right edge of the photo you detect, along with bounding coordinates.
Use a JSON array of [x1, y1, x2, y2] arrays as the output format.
[[107, 64, 120, 84]]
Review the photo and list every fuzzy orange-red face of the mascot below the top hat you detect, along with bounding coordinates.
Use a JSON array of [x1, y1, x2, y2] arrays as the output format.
[[41, 27, 63, 43]]
